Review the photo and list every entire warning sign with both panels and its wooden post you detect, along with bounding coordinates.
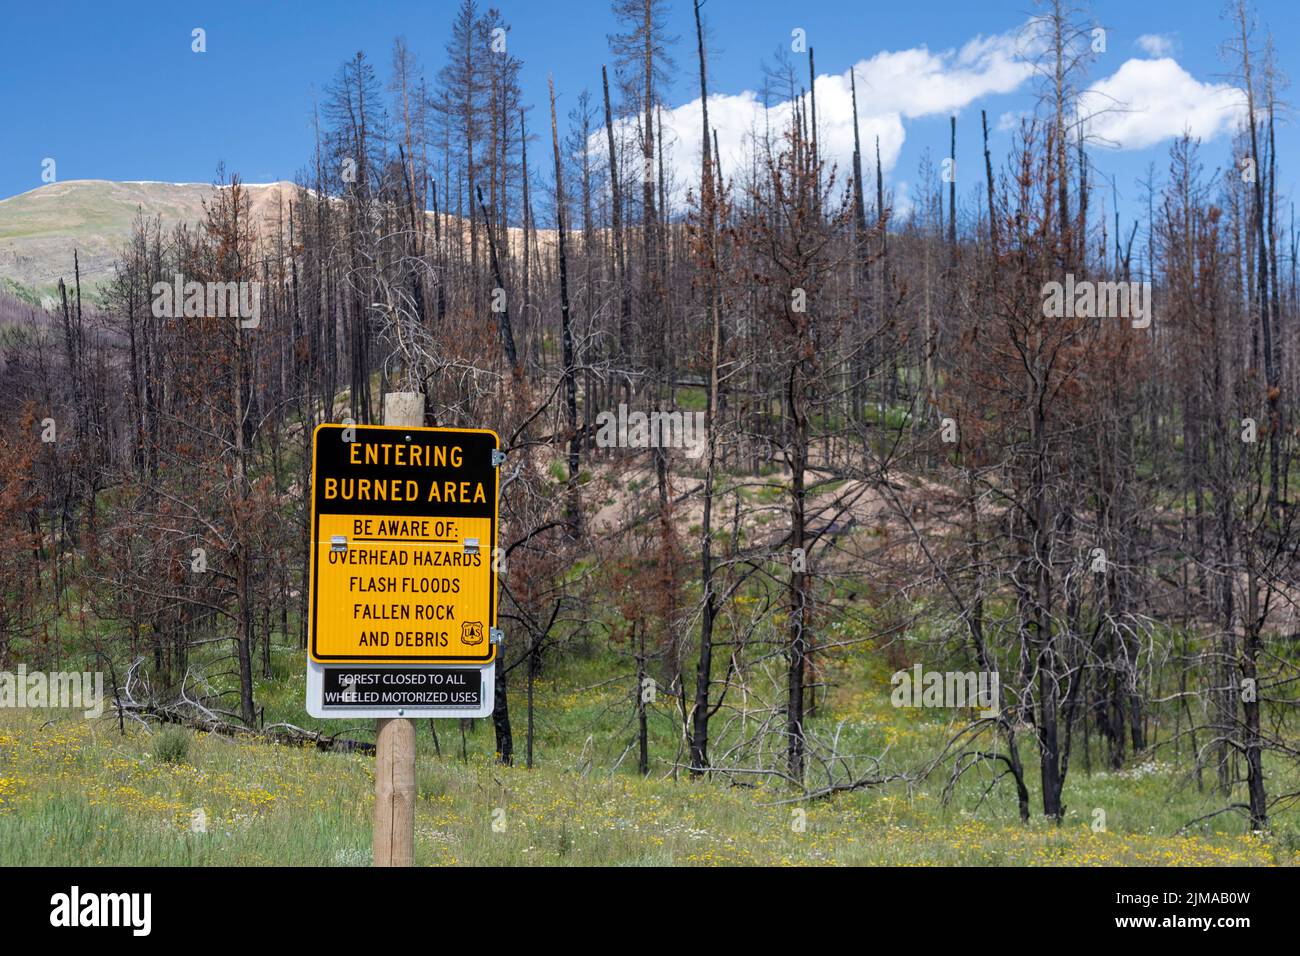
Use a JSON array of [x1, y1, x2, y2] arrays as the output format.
[[307, 392, 504, 866]]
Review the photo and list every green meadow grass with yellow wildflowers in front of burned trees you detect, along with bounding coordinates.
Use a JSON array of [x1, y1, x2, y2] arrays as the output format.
[[0, 634, 1300, 866]]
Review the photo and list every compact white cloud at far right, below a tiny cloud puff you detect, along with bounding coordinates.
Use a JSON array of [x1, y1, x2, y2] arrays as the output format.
[[1079, 57, 1245, 150]]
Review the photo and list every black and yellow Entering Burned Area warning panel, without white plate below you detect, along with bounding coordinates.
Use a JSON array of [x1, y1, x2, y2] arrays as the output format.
[[311, 425, 498, 663]]
